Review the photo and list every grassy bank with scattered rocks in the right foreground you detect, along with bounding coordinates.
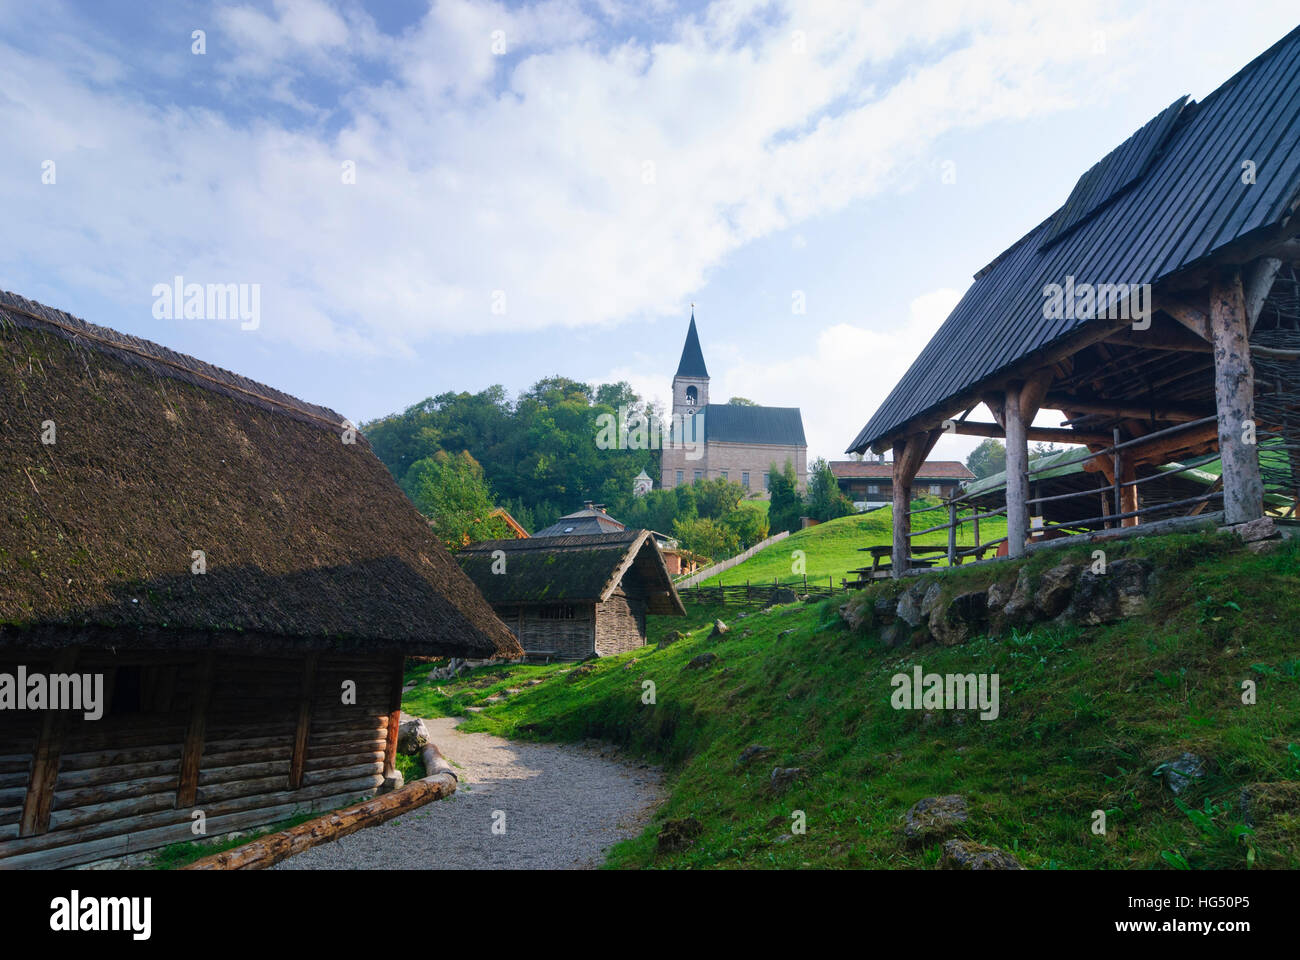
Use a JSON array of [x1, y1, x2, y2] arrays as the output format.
[[404, 522, 1300, 869]]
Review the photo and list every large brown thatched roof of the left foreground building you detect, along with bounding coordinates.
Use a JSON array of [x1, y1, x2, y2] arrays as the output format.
[[0, 293, 520, 657]]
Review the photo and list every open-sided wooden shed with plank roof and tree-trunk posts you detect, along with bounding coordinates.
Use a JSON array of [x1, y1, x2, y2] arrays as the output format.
[[849, 29, 1300, 575]]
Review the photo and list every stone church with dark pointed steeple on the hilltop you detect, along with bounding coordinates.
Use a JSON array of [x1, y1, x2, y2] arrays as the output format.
[[660, 310, 809, 493]]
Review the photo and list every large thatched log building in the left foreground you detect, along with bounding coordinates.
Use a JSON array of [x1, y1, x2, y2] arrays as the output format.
[[0, 294, 520, 869]]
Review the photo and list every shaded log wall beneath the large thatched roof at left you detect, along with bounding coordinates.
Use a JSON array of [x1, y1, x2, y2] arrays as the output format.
[[0, 650, 400, 869]]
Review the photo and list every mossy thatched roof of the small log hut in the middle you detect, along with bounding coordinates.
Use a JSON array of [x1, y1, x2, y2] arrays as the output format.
[[456, 529, 686, 615]]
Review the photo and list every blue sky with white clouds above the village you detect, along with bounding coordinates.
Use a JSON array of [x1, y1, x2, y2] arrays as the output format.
[[0, 0, 1296, 460]]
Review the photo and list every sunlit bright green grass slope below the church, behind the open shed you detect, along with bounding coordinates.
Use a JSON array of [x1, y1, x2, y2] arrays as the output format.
[[701, 501, 1006, 587]]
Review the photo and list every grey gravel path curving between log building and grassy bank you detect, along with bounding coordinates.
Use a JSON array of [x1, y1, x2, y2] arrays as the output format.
[[272, 718, 662, 870]]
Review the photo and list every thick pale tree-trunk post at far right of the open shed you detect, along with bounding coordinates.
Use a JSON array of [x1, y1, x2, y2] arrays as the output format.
[[1210, 268, 1264, 524]]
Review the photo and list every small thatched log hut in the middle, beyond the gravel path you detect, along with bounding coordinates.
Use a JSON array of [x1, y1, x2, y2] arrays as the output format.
[[456, 529, 686, 660]]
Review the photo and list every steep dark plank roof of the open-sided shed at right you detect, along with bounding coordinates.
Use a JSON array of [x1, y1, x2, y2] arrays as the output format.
[[848, 29, 1300, 453]]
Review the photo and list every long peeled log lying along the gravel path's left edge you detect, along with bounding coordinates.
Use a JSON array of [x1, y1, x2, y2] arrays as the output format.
[[182, 748, 456, 870]]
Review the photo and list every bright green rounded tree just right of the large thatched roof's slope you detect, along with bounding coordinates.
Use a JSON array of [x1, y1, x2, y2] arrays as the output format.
[[407, 450, 511, 550]]
